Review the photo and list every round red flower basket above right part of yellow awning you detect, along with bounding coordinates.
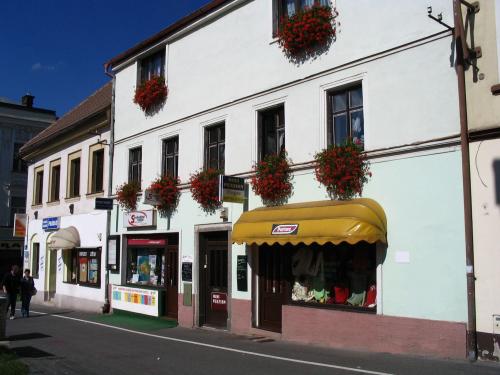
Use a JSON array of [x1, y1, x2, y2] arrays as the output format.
[[314, 140, 372, 200]]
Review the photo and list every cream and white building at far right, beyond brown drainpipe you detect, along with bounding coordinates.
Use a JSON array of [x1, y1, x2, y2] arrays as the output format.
[[463, 0, 500, 361]]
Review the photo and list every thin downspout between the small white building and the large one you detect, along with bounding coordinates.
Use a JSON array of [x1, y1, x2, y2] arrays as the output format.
[[102, 64, 118, 314]]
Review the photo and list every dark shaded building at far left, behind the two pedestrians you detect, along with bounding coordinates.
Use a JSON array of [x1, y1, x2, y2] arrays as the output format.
[[0, 94, 56, 275]]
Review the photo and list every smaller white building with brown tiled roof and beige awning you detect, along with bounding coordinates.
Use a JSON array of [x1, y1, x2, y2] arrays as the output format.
[[20, 83, 111, 311]]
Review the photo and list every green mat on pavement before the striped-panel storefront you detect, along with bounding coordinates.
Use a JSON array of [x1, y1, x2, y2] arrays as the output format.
[[90, 310, 177, 331]]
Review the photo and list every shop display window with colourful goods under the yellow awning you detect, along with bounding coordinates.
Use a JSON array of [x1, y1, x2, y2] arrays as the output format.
[[290, 242, 377, 310]]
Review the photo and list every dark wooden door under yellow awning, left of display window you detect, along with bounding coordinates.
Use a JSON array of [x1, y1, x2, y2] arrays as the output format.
[[259, 245, 288, 332]]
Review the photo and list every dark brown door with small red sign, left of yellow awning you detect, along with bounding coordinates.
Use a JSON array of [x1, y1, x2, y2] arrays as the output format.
[[199, 232, 229, 328]]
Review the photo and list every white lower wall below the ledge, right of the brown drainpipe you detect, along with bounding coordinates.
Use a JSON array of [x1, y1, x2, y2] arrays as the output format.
[[470, 139, 500, 333]]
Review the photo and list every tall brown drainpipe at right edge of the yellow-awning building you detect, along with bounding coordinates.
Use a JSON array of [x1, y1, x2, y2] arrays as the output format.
[[453, 0, 477, 361]]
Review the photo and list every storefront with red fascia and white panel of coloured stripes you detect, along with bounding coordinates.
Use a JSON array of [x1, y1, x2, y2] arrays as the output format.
[[112, 234, 179, 319]]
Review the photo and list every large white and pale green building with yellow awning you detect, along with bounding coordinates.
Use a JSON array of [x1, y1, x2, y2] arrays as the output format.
[[107, 0, 467, 357]]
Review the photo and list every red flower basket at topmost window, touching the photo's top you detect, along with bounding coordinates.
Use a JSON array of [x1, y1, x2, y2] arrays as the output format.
[[278, 5, 335, 58]]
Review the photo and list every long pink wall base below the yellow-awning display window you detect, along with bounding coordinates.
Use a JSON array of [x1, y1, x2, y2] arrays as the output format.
[[282, 306, 466, 358]]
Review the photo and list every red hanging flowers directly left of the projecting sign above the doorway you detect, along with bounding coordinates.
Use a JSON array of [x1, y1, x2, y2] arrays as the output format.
[[189, 168, 222, 214]]
